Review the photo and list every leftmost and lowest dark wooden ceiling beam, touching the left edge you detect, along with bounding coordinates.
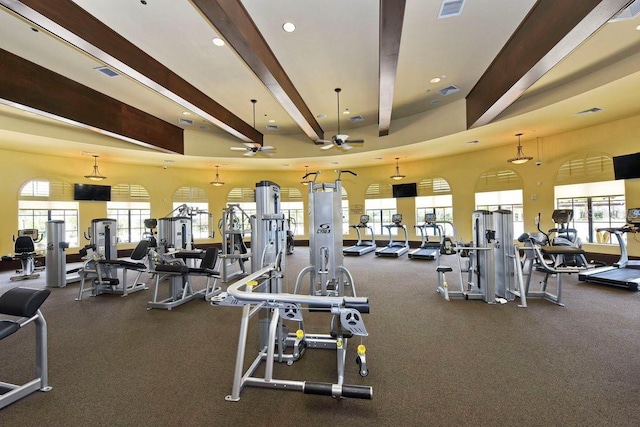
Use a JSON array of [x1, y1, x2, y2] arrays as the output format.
[[0, 49, 184, 154]]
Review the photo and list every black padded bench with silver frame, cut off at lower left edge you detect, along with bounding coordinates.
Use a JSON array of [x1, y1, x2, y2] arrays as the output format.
[[0, 287, 51, 409]]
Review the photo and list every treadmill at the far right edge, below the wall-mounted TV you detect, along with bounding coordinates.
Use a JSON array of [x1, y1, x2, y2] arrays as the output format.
[[578, 208, 640, 291]]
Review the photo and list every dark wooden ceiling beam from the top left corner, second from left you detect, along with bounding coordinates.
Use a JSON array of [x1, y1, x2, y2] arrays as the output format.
[[0, 0, 263, 144]]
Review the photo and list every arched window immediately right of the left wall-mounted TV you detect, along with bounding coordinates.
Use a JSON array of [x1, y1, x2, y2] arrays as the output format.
[[107, 184, 151, 243]]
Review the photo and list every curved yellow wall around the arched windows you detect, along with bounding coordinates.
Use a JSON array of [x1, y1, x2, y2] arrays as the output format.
[[0, 112, 640, 256]]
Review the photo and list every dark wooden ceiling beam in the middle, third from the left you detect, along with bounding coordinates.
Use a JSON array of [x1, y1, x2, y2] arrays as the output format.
[[191, 0, 324, 144]]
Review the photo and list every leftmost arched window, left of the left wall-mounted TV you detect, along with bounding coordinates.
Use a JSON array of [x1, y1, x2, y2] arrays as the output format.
[[18, 179, 80, 251]]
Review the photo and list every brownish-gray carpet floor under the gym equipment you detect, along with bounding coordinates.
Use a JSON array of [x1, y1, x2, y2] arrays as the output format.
[[0, 248, 640, 427]]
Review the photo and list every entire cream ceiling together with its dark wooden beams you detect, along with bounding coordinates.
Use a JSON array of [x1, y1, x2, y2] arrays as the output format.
[[0, 0, 640, 170]]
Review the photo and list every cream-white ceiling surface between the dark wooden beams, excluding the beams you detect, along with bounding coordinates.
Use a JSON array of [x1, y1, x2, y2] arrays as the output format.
[[0, 0, 640, 170]]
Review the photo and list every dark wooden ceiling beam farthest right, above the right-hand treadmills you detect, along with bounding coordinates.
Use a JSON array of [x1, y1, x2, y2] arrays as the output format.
[[466, 0, 630, 128]]
